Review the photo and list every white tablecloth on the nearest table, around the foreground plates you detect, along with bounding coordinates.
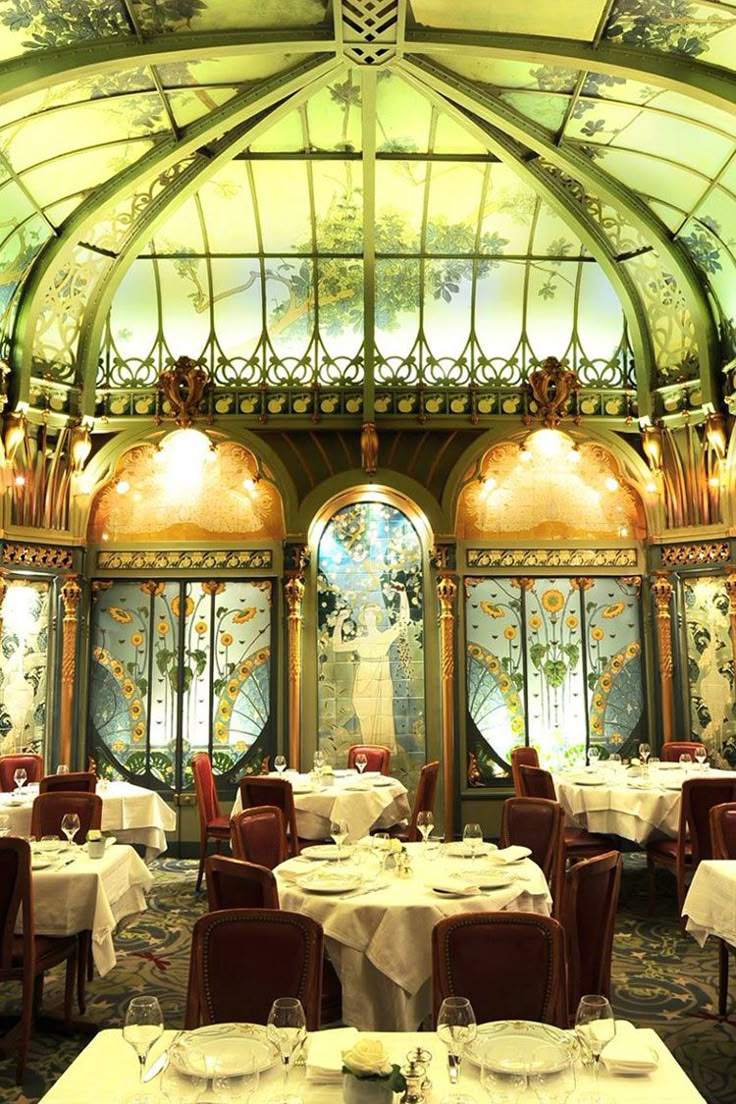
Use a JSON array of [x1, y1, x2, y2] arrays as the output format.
[[41, 1030, 705, 1104]]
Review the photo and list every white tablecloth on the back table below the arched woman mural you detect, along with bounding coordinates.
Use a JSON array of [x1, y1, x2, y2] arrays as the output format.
[[231, 775, 412, 839]]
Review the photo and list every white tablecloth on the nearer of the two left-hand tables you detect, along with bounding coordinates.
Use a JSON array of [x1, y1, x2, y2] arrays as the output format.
[[25, 843, 153, 976]]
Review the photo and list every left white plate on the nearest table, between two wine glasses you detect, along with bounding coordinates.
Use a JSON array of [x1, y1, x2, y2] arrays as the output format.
[[169, 1023, 278, 1078]]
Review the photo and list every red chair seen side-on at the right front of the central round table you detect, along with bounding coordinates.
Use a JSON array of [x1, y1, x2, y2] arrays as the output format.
[[562, 851, 623, 1023]]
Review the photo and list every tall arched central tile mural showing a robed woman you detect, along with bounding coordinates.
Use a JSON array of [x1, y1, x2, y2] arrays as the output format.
[[317, 502, 425, 786]]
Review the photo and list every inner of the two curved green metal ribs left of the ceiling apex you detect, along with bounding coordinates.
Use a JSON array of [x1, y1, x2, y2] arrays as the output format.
[[77, 60, 342, 415]]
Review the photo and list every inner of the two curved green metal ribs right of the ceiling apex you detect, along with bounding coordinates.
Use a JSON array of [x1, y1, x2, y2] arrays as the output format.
[[396, 62, 655, 417]]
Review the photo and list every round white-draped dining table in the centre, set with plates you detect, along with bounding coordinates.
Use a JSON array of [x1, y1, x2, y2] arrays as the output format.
[[274, 842, 552, 1031]]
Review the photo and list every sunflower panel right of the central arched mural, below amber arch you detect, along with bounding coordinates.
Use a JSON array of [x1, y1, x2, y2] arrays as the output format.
[[466, 578, 643, 784]]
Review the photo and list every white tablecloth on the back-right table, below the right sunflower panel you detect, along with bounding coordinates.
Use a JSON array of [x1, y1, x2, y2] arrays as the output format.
[[555, 768, 735, 845]]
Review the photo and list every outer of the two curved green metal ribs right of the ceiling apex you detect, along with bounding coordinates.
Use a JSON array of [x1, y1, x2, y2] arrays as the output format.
[[402, 57, 719, 403]]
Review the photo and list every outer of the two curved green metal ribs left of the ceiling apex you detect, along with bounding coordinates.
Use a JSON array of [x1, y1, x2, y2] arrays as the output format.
[[13, 57, 340, 402]]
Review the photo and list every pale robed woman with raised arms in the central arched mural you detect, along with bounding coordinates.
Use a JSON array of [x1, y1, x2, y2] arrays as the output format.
[[332, 583, 409, 752]]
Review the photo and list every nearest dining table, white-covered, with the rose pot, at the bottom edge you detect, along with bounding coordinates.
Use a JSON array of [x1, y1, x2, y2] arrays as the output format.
[[40, 1025, 706, 1104]]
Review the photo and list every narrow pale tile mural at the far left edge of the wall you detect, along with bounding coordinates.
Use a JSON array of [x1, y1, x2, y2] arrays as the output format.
[[0, 581, 51, 755]]
